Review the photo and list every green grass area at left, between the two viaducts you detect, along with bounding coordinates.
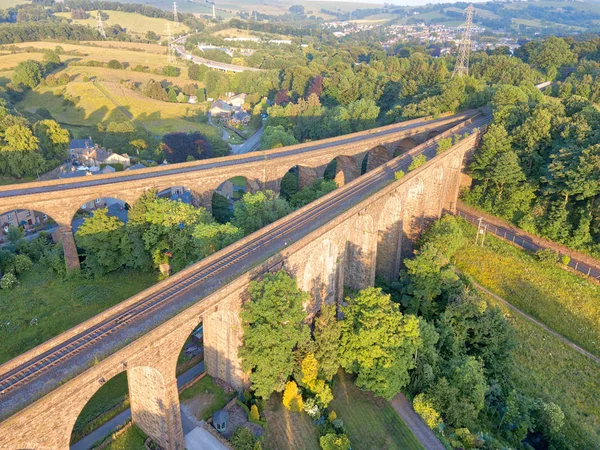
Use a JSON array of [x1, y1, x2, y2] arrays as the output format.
[[0, 264, 158, 363]]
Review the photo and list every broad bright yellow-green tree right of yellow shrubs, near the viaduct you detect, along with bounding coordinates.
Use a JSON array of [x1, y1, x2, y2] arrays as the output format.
[[340, 288, 422, 399]]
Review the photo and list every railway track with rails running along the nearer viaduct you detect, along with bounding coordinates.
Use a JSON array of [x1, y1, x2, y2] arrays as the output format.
[[0, 117, 487, 398]]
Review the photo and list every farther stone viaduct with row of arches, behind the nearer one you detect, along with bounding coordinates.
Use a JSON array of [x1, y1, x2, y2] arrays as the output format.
[[0, 112, 473, 269]]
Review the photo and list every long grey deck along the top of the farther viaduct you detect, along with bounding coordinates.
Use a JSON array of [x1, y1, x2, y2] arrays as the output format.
[[0, 112, 472, 198]]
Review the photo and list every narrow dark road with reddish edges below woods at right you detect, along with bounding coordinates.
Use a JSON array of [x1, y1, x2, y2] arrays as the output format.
[[456, 205, 600, 280]]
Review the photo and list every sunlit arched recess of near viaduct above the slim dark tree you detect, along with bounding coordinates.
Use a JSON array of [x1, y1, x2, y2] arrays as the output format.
[[299, 238, 343, 315]]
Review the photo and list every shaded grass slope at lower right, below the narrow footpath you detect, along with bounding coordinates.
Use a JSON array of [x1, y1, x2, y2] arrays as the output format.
[[488, 297, 600, 450]]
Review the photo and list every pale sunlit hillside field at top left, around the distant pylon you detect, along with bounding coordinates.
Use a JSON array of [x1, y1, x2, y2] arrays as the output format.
[[55, 10, 189, 37]]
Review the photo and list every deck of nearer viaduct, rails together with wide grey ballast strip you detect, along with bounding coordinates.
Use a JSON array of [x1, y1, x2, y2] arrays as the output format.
[[0, 116, 488, 416]]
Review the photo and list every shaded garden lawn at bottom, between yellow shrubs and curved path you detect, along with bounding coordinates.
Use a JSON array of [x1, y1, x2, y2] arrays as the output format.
[[330, 373, 423, 450]]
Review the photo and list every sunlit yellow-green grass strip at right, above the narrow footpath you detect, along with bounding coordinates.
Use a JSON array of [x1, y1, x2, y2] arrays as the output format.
[[454, 229, 600, 356]]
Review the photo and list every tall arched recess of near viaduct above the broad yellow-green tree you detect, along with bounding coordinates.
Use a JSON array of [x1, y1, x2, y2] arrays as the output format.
[[344, 213, 377, 290]]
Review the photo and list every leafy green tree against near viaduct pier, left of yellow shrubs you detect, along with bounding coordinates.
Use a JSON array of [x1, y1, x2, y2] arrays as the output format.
[[240, 271, 310, 398]]
